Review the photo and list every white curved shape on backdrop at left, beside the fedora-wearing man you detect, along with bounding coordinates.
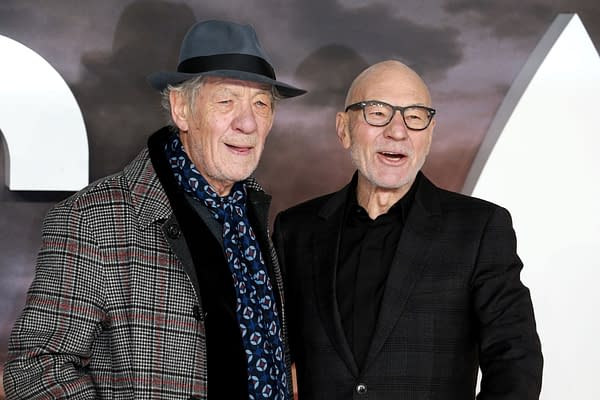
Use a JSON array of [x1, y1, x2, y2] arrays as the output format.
[[0, 35, 89, 191]]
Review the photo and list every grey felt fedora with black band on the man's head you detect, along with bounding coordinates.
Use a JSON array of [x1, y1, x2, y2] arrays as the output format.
[[148, 20, 306, 97]]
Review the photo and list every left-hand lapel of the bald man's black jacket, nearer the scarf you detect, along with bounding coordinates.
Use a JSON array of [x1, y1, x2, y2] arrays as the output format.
[[312, 186, 358, 376]]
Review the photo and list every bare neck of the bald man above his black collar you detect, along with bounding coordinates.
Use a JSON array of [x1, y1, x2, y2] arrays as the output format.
[[356, 174, 413, 219]]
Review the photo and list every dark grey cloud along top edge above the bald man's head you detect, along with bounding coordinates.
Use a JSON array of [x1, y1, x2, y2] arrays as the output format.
[[282, 0, 462, 78]]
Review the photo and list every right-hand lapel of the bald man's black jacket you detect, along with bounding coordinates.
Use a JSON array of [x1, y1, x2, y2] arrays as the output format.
[[365, 176, 440, 370]]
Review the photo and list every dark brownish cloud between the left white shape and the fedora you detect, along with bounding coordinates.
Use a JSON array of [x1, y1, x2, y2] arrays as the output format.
[[71, 0, 195, 180]]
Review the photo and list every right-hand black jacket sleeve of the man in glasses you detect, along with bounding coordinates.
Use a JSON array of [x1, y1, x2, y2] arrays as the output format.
[[471, 208, 543, 400]]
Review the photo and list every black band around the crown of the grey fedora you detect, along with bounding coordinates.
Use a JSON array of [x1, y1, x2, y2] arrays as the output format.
[[177, 54, 275, 80]]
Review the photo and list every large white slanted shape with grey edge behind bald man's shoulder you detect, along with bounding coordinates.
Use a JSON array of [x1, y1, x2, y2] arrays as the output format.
[[463, 14, 600, 400]]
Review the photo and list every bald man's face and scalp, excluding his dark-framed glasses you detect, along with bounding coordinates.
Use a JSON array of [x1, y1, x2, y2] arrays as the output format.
[[336, 61, 435, 197]]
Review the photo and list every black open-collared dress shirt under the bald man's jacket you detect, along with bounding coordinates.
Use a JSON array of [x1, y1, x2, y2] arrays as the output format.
[[336, 175, 418, 368]]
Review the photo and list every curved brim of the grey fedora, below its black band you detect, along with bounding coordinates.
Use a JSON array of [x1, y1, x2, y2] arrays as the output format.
[[147, 69, 306, 98]]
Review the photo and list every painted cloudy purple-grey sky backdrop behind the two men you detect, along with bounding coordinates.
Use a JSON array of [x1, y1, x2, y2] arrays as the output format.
[[0, 0, 600, 396]]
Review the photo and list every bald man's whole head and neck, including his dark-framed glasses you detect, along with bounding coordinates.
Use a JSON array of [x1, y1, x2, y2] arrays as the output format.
[[336, 60, 435, 212]]
